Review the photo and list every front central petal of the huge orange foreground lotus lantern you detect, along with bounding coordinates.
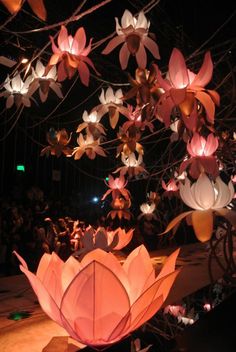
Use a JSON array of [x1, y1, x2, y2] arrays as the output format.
[[61, 261, 130, 345]]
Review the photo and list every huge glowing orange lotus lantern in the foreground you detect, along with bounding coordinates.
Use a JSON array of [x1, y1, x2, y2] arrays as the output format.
[[13, 246, 179, 349]]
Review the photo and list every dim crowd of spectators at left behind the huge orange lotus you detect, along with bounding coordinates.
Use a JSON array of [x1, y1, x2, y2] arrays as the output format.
[[0, 187, 166, 276]]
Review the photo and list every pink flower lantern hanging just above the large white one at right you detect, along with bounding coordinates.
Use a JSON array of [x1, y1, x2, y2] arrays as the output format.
[[179, 133, 219, 179]]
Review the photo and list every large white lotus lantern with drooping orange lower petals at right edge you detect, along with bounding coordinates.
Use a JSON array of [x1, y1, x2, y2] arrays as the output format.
[[164, 173, 236, 242]]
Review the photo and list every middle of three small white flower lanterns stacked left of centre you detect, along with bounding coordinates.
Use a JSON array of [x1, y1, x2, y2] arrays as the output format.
[[76, 110, 106, 138]]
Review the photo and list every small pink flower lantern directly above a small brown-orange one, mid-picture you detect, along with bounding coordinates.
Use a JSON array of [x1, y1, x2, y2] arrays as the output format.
[[102, 175, 130, 200]]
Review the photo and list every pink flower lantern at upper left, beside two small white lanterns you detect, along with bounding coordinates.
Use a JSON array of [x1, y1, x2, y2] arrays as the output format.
[[49, 26, 98, 86]]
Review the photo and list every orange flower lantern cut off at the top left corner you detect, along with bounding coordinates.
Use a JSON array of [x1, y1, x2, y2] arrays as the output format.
[[1, 0, 47, 21]]
